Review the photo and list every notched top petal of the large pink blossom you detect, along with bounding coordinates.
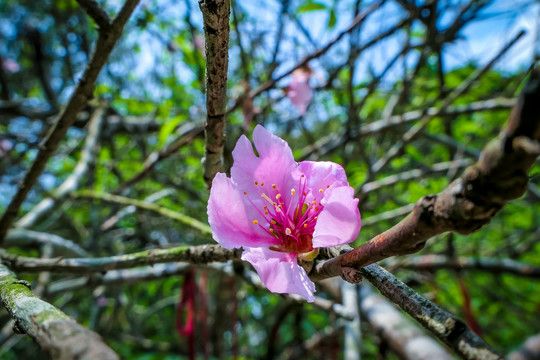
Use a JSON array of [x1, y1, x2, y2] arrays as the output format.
[[231, 125, 299, 198]]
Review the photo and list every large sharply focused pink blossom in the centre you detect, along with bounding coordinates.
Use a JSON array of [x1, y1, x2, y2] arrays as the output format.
[[208, 125, 360, 302]]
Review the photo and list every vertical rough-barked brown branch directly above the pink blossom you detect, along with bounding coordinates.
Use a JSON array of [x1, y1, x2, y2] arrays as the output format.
[[199, 0, 231, 189]]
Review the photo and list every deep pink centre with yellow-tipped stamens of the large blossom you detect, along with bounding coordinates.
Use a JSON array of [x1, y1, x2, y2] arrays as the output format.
[[244, 175, 329, 253]]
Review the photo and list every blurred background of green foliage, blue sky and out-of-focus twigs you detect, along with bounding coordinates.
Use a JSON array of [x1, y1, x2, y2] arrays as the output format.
[[0, 0, 540, 359]]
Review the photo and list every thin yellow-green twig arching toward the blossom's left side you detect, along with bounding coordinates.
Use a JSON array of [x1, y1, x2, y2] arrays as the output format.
[[71, 190, 212, 234]]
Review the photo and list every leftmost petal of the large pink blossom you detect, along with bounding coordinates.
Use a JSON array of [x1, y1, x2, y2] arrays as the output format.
[[207, 173, 277, 249]]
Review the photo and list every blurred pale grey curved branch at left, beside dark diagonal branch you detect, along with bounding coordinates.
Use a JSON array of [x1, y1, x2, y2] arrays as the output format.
[[15, 107, 104, 228]]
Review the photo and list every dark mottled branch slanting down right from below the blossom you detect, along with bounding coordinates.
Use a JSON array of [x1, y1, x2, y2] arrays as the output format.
[[360, 264, 502, 360]]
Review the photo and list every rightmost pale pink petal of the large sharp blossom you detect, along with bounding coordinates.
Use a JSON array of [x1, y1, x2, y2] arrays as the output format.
[[313, 186, 361, 248]]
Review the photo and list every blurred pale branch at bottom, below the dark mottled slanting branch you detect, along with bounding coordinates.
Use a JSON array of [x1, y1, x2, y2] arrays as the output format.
[[360, 282, 454, 360]]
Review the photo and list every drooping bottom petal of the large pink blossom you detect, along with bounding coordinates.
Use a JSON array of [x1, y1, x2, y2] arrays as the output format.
[[242, 248, 315, 302]]
